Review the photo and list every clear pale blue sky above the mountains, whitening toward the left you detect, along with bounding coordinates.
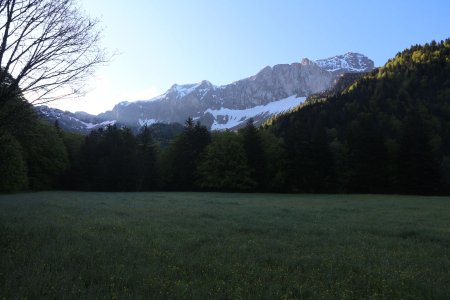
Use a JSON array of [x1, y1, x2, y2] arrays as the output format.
[[49, 0, 450, 114]]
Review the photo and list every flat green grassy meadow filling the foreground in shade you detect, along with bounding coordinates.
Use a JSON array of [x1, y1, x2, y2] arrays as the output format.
[[0, 192, 450, 299]]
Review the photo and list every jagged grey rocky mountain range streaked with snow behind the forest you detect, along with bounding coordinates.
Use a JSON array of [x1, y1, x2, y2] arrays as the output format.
[[36, 52, 374, 133]]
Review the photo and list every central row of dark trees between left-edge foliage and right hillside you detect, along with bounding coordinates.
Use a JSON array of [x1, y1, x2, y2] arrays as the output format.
[[60, 119, 283, 191]]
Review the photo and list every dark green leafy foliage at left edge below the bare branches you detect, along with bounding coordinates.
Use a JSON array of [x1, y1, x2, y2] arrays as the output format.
[[0, 78, 68, 191]]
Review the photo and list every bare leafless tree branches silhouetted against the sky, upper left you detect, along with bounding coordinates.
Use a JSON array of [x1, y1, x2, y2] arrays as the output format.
[[0, 0, 109, 109]]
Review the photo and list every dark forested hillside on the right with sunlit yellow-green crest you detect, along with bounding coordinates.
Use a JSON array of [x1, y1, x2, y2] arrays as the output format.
[[269, 39, 450, 194]]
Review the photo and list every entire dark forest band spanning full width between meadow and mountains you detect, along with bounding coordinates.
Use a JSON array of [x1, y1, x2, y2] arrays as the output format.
[[0, 39, 450, 195]]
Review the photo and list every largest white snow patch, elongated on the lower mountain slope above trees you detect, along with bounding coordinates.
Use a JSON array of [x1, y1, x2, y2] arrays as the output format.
[[205, 95, 306, 130]]
